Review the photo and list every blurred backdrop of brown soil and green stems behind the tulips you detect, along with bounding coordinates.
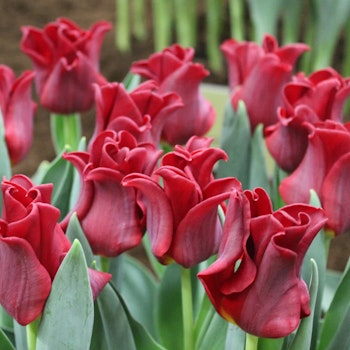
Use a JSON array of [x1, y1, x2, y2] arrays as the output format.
[[0, 0, 350, 270]]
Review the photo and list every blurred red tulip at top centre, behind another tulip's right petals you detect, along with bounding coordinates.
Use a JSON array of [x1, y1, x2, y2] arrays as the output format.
[[131, 44, 215, 145]]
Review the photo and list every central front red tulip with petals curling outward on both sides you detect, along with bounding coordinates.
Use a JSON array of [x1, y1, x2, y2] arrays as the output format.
[[123, 137, 241, 267]]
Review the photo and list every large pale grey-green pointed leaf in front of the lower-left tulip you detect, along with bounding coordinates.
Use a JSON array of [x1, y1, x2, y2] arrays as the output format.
[[37, 240, 94, 350]]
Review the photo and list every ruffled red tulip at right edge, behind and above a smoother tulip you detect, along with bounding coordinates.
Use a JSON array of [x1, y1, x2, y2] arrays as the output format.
[[264, 68, 350, 173]]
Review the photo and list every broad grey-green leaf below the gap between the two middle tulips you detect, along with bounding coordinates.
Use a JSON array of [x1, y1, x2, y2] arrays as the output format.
[[116, 255, 157, 337]]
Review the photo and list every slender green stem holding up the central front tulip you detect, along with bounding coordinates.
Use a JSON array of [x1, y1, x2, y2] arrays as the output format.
[[181, 267, 194, 350]]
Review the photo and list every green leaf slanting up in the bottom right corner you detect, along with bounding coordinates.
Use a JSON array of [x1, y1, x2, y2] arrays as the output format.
[[318, 259, 350, 350]]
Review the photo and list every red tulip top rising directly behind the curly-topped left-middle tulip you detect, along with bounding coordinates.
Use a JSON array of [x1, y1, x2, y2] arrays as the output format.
[[90, 80, 182, 147]]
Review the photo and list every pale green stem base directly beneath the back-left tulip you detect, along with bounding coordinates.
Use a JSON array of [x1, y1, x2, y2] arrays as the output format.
[[50, 113, 81, 154]]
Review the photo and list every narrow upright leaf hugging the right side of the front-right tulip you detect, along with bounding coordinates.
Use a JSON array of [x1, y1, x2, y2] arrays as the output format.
[[289, 259, 319, 350]]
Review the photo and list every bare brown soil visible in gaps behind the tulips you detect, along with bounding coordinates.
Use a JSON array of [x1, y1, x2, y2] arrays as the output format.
[[0, 0, 350, 270]]
